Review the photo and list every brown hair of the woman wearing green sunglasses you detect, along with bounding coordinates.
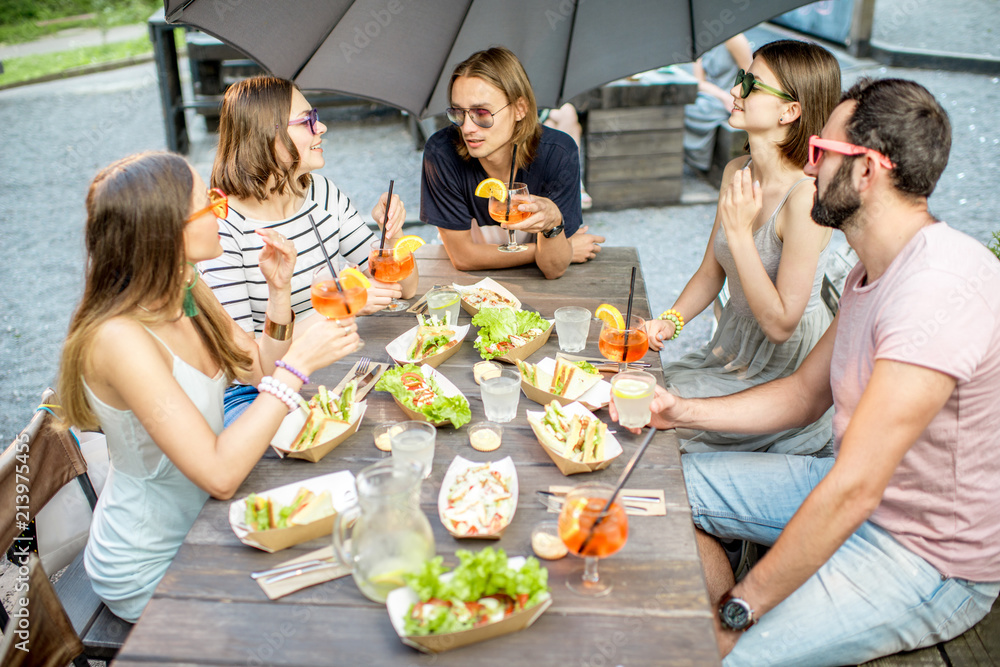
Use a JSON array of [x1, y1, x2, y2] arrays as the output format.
[[753, 39, 840, 168]]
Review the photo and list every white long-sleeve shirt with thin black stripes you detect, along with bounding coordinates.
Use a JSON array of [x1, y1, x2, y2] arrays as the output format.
[[198, 174, 374, 334]]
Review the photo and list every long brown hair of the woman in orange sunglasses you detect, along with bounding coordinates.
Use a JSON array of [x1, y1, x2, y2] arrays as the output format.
[[59, 152, 252, 430]]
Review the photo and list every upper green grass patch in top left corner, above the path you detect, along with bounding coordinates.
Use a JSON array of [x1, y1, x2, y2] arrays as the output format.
[[0, 0, 163, 45]]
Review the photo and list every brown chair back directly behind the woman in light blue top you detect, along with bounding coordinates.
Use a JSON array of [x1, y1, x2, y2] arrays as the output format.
[[0, 389, 87, 550]]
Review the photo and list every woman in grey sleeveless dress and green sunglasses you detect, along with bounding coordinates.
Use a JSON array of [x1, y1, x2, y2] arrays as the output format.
[[646, 40, 840, 455]]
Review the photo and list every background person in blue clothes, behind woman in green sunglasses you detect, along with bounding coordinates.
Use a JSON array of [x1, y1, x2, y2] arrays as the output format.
[[684, 33, 753, 172]]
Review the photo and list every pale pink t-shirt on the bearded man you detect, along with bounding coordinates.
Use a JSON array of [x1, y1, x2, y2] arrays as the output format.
[[830, 222, 1000, 582]]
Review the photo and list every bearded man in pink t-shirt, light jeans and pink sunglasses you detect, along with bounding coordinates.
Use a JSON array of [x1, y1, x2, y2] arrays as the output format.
[[612, 79, 1000, 665]]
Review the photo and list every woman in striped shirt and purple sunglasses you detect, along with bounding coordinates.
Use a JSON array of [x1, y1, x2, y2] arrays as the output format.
[[199, 76, 419, 425]]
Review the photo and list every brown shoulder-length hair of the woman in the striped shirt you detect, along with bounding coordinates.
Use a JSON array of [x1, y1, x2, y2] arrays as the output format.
[[212, 75, 309, 201]]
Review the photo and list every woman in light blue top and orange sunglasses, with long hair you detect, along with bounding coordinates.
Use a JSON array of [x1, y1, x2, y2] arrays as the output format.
[[59, 153, 358, 622]]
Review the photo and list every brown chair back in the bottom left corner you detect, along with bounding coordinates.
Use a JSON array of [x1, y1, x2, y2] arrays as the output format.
[[0, 555, 83, 667]]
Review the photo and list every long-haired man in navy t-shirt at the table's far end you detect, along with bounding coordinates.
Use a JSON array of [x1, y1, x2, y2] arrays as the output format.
[[420, 47, 604, 278]]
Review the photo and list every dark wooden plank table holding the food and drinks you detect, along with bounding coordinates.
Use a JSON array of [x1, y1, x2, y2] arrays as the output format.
[[115, 245, 719, 665]]
